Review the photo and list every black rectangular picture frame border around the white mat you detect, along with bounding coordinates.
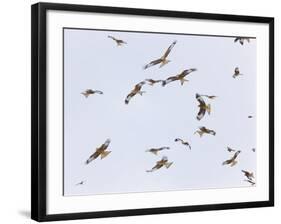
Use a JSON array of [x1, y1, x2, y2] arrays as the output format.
[[31, 3, 274, 221]]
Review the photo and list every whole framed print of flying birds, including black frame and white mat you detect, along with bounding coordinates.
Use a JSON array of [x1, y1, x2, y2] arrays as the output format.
[[31, 3, 274, 221]]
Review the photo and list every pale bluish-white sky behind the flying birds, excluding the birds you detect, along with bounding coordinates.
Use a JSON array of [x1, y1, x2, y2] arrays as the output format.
[[64, 29, 259, 196]]
